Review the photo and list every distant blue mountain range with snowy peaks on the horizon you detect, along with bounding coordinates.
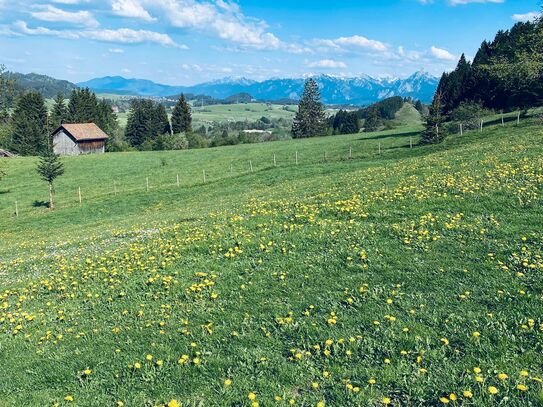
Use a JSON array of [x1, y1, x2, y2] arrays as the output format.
[[78, 72, 439, 105]]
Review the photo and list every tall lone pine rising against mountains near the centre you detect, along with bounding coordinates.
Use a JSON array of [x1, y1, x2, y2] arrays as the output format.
[[292, 78, 326, 138]]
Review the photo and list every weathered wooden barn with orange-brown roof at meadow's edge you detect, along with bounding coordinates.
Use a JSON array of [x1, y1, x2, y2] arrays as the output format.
[[53, 123, 108, 155]]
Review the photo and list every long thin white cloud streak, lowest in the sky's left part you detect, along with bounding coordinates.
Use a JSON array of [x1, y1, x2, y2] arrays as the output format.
[[13, 21, 187, 49]]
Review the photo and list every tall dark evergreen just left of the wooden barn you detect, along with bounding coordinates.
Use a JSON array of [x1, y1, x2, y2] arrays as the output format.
[[11, 91, 49, 155]]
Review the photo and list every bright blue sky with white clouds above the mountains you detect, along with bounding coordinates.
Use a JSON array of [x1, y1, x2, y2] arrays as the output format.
[[0, 0, 541, 85]]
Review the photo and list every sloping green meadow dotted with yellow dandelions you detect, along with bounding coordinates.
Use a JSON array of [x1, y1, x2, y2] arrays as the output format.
[[0, 116, 543, 407]]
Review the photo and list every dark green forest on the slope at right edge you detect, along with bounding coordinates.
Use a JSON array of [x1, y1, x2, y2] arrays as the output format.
[[422, 18, 543, 143]]
